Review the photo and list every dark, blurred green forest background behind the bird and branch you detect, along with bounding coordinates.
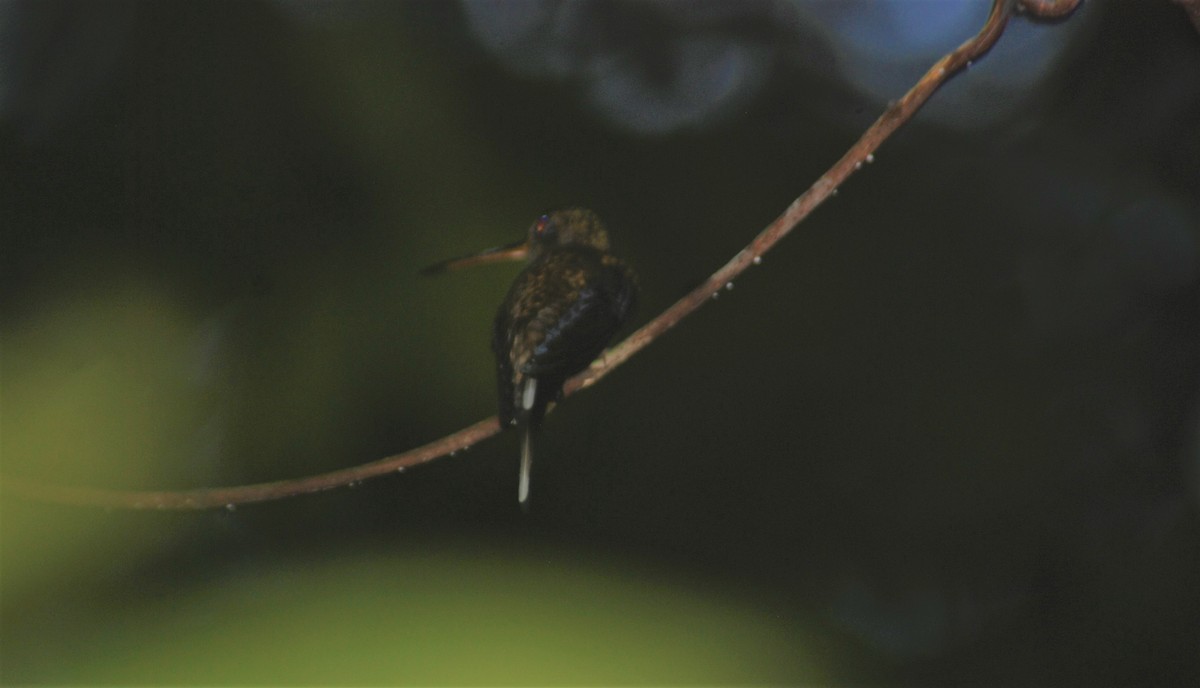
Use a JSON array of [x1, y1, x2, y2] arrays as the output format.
[[0, 2, 1200, 686]]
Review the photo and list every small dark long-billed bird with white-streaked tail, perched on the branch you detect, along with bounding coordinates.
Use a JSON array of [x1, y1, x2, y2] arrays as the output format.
[[422, 208, 637, 508]]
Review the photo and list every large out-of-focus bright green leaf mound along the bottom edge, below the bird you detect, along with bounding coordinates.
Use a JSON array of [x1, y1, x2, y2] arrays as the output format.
[[5, 539, 823, 686]]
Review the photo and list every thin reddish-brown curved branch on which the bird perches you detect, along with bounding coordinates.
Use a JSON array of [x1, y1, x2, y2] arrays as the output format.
[[7, 0, 1022, 509]]
